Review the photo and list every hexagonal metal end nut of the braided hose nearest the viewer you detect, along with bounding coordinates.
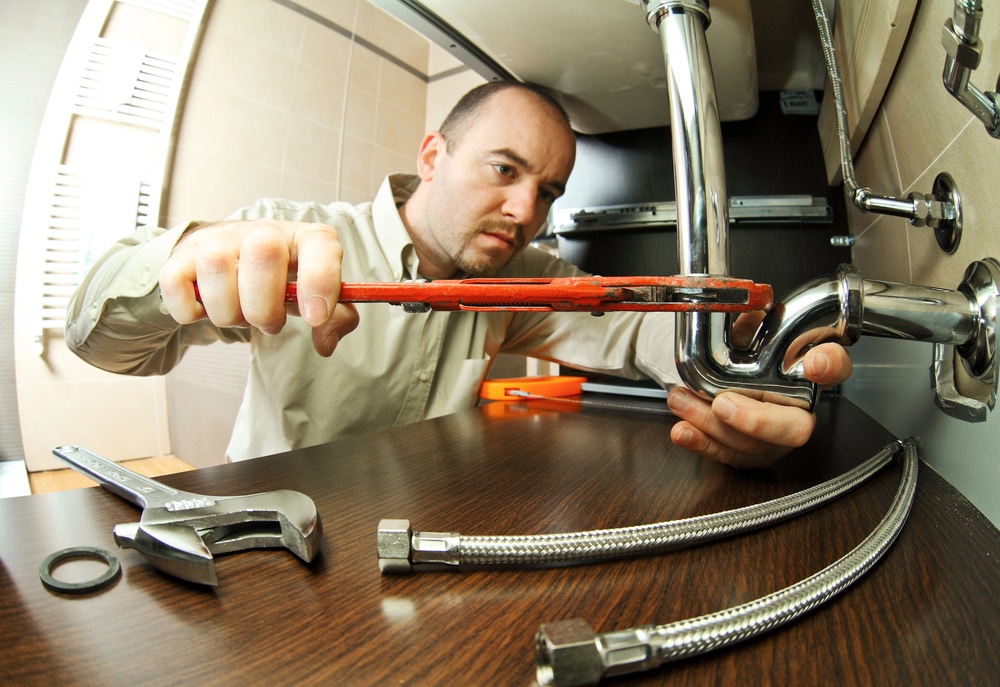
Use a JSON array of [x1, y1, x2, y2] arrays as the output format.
[[535, 618, 604, 687]]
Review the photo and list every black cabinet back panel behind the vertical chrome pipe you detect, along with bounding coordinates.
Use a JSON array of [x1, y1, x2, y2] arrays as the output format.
[[559, 93, 851, 298]]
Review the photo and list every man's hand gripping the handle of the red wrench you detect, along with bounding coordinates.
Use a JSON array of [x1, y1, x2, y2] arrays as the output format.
[[159, 220, 358, 356]]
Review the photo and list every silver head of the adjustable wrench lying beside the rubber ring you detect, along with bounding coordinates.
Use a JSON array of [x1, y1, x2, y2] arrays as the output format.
[[115, 490, 323, 586]]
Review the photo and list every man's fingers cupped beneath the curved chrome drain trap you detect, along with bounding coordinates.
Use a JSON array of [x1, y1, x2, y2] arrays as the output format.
[[667, 388, 815, 467]]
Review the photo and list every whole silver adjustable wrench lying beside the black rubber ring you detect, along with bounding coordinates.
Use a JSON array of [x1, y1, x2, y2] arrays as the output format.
[[52, 446, 323, 586]]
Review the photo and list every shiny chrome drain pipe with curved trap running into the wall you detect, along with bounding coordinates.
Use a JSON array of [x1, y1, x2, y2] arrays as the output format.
[[640, 0, 1000, 418]]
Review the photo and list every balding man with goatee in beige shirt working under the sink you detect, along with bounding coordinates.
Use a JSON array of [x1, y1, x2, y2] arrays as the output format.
[[66, 82, 850, 465]]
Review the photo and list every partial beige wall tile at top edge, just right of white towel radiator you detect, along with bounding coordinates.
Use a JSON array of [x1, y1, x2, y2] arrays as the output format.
[[207, 0, 304, 60]]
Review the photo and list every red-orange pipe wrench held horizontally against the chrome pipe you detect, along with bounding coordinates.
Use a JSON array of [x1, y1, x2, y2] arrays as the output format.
[[238, 276, 773, 312]]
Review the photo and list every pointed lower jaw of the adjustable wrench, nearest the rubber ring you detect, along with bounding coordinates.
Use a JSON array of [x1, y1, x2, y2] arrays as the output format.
[[114, 522, 219, 587]]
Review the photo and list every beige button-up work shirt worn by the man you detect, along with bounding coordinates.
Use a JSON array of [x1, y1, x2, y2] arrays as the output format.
[[66, 175, 678, 460]]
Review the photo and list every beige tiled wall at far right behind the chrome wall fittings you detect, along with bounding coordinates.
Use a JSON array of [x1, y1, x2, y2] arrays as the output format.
[[845, 0, 1000, 522]]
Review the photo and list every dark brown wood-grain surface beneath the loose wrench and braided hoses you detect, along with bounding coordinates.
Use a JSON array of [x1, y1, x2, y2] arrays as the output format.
[[0, 397, 1000, 687]]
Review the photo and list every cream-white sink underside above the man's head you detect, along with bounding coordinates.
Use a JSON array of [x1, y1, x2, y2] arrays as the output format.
[[421, 0, 758, 133]]
